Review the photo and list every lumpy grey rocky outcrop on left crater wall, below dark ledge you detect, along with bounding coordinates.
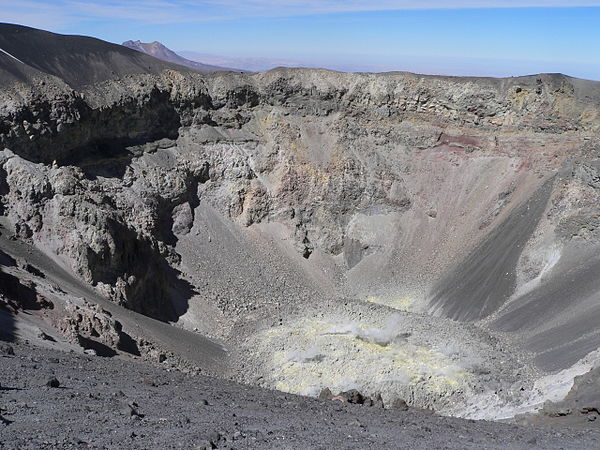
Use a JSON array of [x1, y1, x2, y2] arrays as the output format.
[[4, 152, 202, 320]]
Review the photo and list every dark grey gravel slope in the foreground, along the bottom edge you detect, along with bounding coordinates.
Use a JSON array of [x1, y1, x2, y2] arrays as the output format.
[[0, 342, 600, 449]]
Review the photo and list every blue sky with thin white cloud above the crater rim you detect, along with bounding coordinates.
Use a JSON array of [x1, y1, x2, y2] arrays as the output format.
[[0, 0, 600, 80]]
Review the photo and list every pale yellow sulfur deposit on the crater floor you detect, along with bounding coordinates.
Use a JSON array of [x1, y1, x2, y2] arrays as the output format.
[[264, 321, 470, 406]]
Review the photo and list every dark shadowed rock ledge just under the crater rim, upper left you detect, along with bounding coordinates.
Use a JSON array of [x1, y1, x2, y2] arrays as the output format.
[[0, 82, 180, 165]]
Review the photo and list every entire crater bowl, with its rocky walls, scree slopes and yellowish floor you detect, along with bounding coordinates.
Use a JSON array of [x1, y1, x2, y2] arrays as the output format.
[[0, 24, 600, 432]]
